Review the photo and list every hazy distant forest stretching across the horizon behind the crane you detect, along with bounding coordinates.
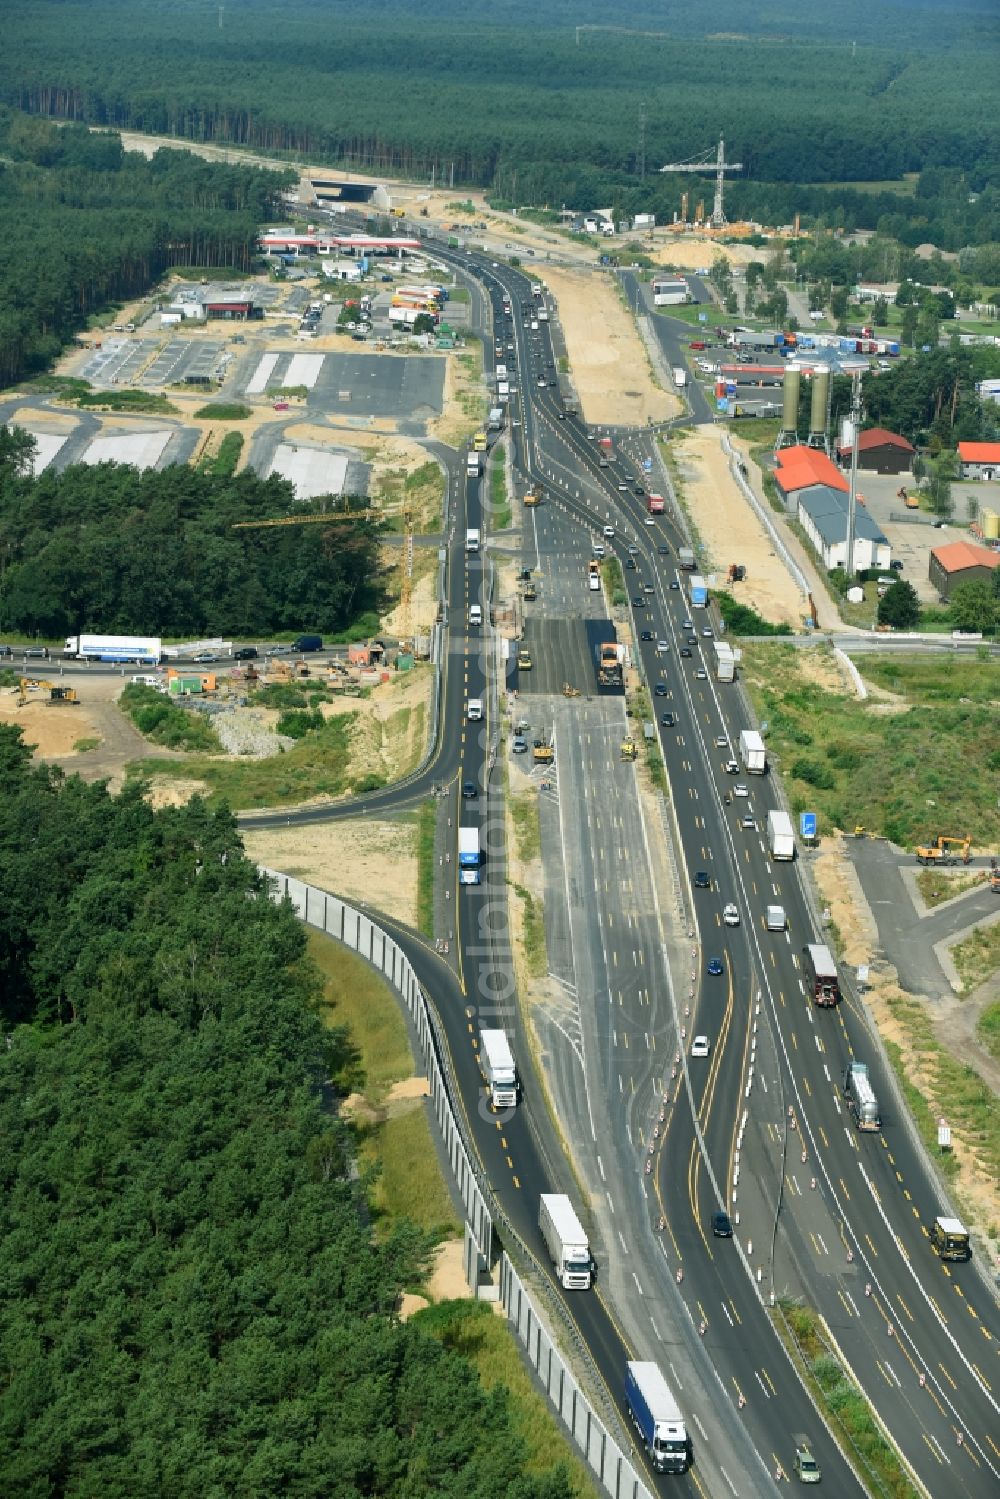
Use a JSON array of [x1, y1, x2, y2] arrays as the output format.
[[0, 0, 1000, 247]]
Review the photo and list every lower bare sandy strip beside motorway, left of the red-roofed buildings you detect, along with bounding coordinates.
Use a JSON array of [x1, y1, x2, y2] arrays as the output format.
[[670, 427, 805, 630]]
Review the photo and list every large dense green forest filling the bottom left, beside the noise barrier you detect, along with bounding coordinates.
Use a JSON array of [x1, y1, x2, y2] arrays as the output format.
[[0, 740, 570, 1499]]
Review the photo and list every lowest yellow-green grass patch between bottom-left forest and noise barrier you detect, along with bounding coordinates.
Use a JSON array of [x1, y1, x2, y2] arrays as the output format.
[[414, 1301, 598, 1499]]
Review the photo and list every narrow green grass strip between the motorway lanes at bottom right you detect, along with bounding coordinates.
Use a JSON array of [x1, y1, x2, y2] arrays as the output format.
[[774, 1301, 918, 1499]]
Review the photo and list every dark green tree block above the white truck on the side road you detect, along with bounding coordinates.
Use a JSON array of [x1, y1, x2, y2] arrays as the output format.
[[0, 429, 381, 639]]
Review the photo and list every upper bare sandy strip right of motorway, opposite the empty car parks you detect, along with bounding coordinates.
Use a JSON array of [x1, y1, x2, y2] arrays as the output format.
[[540, 265, 681, 427]]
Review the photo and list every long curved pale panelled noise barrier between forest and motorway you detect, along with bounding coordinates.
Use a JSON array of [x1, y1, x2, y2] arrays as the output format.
[[261, 866, 654, 1499]]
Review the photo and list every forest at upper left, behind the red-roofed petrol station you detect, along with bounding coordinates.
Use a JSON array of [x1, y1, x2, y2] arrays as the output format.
[[0, 109, 285, 385]]
